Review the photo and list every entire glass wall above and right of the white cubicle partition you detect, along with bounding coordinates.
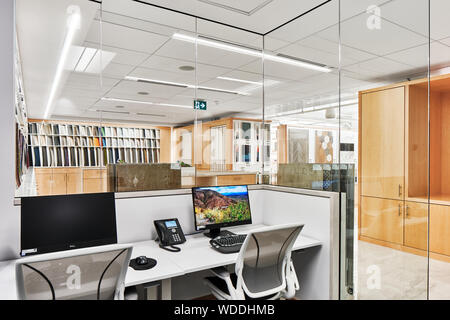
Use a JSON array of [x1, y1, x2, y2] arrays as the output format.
[[11, 0, 450, 299]]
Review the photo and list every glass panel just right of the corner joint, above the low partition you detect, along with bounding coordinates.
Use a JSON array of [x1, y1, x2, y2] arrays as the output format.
[[264, 2, 340, 191]]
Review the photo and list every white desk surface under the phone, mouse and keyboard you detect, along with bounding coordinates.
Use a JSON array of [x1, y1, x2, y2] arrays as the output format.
[[0, 225, 321, 300]]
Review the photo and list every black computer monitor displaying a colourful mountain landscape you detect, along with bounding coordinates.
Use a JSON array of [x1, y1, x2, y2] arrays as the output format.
[[192, 186, 252, 238]]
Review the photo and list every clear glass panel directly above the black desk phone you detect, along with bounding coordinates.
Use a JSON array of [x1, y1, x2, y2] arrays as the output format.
[[98, 1, 198, 192]]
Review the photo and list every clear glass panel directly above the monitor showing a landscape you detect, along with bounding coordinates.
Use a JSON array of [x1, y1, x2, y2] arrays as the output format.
[[194, 19, 264, 186]]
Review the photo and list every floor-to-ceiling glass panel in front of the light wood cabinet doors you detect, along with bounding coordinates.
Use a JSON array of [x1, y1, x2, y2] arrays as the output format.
[[342, 0, 430, 299]]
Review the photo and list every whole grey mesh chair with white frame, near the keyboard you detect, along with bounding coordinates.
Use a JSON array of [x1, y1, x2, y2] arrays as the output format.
[[205, 224, 303, 300]]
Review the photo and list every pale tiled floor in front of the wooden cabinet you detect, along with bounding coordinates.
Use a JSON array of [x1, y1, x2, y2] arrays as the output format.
[[355, 241, 450, 300]]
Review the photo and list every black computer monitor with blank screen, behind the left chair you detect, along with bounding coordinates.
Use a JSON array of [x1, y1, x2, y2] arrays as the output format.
[[20, 193, 117, 256]]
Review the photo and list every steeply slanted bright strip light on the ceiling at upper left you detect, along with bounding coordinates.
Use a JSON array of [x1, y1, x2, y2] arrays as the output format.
[[44, 6, 81, 119]]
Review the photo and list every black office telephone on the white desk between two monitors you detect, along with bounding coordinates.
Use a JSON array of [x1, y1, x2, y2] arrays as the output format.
[[154, 218, 186, 252]]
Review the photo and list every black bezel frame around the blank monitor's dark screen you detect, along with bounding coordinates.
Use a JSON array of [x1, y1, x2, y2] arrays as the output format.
[[19, 192, 117, 257]]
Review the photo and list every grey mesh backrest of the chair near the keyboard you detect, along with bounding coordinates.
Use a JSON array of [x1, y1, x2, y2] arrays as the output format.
[[236, 224, 303, 298]]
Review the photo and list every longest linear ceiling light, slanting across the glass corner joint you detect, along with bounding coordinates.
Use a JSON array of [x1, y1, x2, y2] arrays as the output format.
[[172, 33, 331, 72]]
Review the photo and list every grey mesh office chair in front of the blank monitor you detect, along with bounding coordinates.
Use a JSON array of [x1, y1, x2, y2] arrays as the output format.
[[16, 245, 132, 300]]
